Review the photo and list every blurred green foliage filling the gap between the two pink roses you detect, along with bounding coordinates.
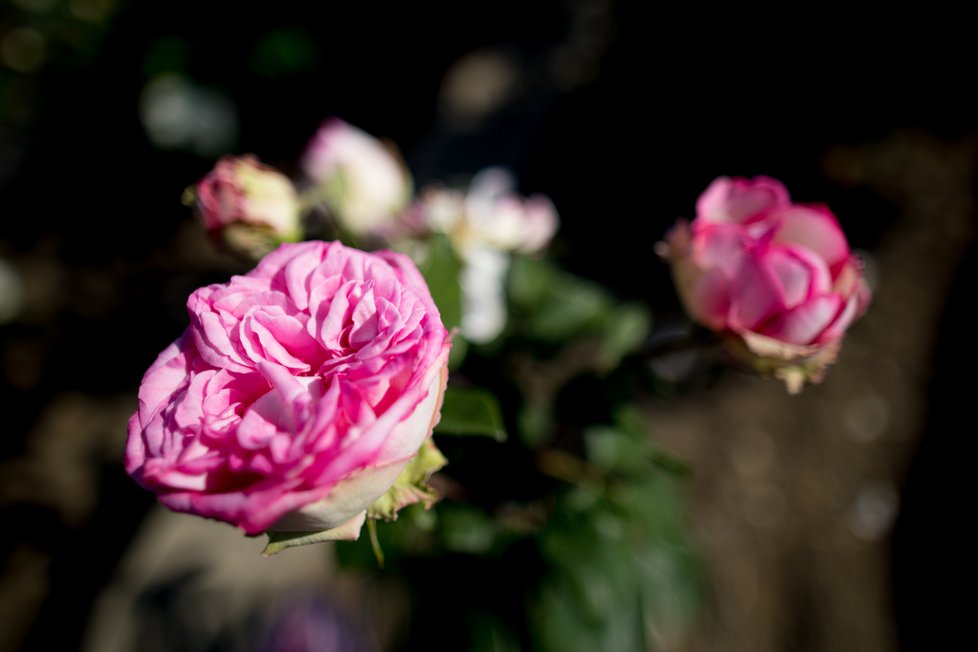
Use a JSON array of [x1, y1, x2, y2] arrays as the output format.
[[336, 246, 704, 652]]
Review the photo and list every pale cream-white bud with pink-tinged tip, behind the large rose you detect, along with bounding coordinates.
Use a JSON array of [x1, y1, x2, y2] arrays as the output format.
[[301, 118, 414, 236]]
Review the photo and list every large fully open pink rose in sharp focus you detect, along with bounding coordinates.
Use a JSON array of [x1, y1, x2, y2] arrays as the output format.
[[126, 241, 451, 538]]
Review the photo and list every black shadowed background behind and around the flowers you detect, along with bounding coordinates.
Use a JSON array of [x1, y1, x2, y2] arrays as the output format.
[[0, 0, 978, 650]]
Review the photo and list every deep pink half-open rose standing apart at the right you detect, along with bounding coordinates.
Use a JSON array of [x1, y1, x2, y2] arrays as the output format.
[[659, 177, 870, 393]]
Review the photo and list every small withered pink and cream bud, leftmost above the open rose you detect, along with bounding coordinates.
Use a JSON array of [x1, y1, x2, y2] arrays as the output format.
[[196, 155, 302, 259]]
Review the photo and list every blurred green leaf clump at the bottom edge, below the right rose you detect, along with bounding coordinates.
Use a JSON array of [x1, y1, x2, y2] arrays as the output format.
[[534, 405, 704, 651]]
